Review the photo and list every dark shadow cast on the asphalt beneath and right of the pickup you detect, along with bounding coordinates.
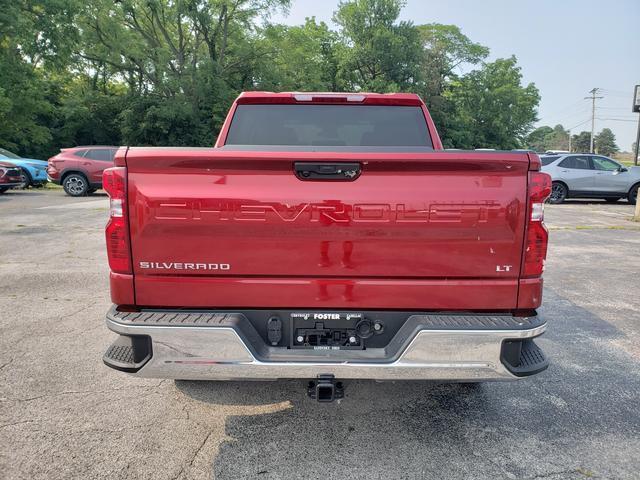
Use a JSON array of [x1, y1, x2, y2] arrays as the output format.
[[176, 291, 640, 479]]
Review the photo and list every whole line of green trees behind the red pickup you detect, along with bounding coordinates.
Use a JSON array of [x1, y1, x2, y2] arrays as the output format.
[[0, 0, 539, 157]]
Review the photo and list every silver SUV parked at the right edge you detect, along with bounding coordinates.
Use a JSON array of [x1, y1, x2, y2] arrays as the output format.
[[540, 153, 640, 204]]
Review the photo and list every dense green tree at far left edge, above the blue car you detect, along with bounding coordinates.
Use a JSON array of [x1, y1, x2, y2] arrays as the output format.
[[0, 0, 78, 157]]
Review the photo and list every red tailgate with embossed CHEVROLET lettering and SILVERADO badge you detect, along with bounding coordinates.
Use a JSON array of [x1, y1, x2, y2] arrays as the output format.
[[127, 148, 528, 308]]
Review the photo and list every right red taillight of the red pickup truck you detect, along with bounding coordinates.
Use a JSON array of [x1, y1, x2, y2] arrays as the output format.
[[522, 172, 551, 277]]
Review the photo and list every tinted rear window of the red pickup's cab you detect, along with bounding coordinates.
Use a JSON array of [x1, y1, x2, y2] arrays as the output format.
[[225, 105, 433, 148]]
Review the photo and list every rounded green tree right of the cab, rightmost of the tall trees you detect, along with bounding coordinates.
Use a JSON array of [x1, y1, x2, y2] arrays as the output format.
[[447, 57, 540, 149]]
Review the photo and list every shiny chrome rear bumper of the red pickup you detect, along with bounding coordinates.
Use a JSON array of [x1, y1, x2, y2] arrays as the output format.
[[105, 309, 546, 382]]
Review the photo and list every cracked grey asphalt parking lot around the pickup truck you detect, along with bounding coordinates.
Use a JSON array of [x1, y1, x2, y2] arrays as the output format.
[[0, 190, 640, 479]]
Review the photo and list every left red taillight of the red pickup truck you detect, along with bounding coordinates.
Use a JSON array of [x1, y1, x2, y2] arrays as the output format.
[[102, 167, 131, 273]]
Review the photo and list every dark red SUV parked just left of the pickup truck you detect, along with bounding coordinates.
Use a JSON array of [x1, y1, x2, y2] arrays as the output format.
[[47, 145, 118, 197]]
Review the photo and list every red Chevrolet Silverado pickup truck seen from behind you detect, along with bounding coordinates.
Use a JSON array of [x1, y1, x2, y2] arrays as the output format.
[[104, 92, 551, 401]]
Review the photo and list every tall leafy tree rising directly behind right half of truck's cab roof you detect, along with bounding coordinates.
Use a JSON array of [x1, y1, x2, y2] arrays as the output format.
[[333, 0, 422, 92]]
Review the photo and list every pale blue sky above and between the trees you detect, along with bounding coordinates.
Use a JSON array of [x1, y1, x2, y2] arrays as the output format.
[[271, 0, 640, 150]]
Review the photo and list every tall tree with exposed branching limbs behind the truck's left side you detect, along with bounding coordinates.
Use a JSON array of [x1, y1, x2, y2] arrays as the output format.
[[77, 0, 289, 145]]
